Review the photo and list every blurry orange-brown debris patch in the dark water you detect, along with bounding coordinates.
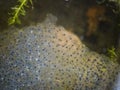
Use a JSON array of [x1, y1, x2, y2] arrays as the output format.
[[86, 6, 106, 36]]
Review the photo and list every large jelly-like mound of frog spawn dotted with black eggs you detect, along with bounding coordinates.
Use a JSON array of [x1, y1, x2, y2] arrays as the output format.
[[0, 14, 119, 90]]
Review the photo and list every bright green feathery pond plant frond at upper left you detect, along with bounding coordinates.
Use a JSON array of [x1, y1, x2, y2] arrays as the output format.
[[8, 0, 33, 25]]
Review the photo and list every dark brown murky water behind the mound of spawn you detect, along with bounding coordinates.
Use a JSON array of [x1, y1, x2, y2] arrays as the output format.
[[0, 0, 120, 59]]
